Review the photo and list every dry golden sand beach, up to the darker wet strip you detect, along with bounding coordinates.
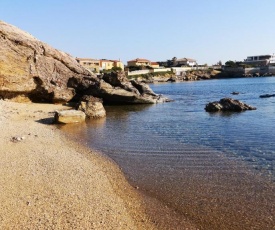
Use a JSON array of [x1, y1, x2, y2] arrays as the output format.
[[0, 101, 155, 229]]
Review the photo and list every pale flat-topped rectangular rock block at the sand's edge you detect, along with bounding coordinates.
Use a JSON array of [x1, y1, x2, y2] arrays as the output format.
[[54, 110, 86, 124]]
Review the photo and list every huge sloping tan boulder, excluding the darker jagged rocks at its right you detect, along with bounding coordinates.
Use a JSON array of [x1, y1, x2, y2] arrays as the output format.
[[0, 21, 95, 103]]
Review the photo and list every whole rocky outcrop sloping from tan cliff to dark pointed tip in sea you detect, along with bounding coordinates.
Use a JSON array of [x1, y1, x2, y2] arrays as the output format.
[[0, 21, 168, 103]]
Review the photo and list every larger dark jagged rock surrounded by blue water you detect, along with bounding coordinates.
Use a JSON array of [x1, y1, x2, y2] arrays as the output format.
[[205, 98, 256, 112]]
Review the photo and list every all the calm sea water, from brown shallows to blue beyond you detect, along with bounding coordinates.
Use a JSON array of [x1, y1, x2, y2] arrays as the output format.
[[64, 77, 275, 229]]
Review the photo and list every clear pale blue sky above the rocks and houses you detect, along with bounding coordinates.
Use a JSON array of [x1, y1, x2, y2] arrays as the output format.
[[0, 0, 275, 65]]
